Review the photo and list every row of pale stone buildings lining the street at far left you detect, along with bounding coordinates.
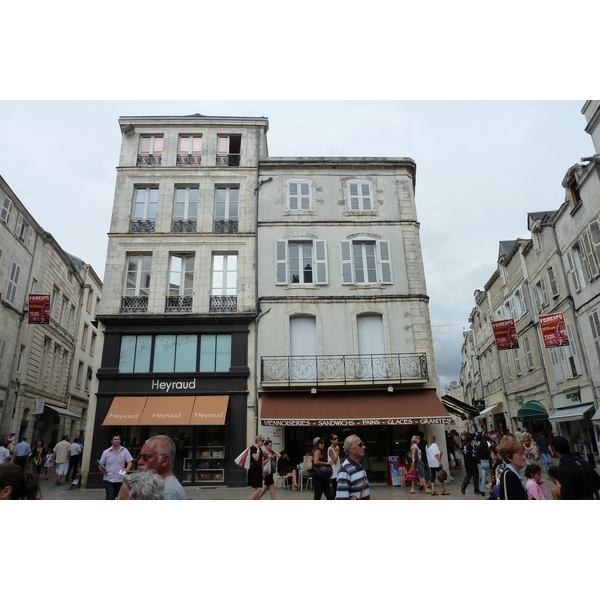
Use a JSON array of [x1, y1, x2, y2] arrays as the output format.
[[0, 177, 102, 447]]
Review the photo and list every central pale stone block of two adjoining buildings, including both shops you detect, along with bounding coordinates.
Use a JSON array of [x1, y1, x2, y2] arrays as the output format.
[[88, 114, 451, 486]]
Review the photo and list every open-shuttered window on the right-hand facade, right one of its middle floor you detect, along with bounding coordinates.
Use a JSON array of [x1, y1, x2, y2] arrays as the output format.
[[341, 239, 393, 285]]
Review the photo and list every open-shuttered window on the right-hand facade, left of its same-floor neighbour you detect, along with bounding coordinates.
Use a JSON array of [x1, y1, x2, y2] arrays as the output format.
[[275, 239, 329, 285]]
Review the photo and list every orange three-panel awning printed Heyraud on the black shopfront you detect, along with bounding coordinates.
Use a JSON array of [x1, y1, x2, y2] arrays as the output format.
[[102, 396, 229, 425]]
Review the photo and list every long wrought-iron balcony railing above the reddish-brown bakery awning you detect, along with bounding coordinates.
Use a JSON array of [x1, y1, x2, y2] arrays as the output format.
[[261, 354, 429, 386]]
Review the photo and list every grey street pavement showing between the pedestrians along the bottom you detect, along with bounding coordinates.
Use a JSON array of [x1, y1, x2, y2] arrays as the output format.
[[35, 471, 554, 502]]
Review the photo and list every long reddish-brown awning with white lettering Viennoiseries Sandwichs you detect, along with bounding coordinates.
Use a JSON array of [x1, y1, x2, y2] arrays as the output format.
[[260, 390, 452, 427]]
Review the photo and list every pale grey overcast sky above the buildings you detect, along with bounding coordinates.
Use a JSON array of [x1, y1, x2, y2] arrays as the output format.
[[0, 100, 593, 391]]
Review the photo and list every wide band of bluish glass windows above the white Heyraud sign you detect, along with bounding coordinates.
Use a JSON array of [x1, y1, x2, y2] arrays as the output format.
[[119, 334, 231, 373]]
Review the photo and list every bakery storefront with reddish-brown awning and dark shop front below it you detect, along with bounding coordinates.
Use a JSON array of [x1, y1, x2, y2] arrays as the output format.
[[260, 389, 453, 481]]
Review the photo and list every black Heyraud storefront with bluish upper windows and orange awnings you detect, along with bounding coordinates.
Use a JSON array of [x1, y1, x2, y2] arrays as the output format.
[[87, 315, 252, 487]]
